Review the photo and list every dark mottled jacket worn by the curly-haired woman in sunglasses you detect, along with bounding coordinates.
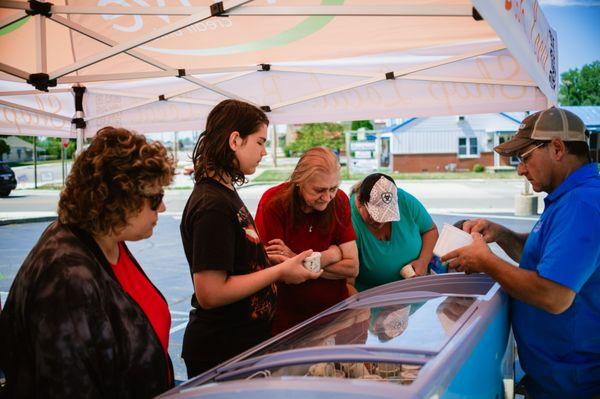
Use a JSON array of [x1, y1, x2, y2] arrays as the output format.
[[0, 222, 173, 398]]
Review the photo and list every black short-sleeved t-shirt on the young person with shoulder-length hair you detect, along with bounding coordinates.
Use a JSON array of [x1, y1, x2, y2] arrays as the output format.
[[181, 178, 276, 362]]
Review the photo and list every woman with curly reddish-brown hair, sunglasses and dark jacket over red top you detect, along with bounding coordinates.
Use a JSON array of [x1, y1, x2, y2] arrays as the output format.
[[0, 127, 174, 398]]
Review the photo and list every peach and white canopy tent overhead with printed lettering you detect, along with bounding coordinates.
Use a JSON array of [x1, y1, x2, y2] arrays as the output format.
[[0, 0, 558, 150]]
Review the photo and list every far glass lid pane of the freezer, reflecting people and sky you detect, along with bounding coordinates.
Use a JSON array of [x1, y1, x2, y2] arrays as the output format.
[[252, 296, 475, 357]]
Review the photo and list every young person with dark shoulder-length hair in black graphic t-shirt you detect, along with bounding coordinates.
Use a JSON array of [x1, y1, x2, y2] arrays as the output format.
[[181, 100, 320, 378]]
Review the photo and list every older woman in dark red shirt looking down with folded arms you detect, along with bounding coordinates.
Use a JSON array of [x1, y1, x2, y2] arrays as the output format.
[[256, 147, 358, 334]]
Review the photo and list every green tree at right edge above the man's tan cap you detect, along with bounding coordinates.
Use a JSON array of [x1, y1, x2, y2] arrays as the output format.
[[558, 61, 600, 105]]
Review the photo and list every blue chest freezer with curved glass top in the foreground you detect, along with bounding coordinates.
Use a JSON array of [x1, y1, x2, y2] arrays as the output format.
[[161, 273, 514, 399]]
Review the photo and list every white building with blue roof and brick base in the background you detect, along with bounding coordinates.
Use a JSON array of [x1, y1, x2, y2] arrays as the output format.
[[380, 106, 600, 172]]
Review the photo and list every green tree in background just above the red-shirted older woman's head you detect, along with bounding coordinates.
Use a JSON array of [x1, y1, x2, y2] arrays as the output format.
[[285, 123, 344, 152]]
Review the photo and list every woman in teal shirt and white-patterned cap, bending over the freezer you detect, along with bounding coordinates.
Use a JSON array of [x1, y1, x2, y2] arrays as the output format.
[[350, 173, 438, 291]]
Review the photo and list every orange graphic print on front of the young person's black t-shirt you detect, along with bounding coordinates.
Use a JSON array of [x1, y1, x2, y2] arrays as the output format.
[[237, 206, 276, 319]]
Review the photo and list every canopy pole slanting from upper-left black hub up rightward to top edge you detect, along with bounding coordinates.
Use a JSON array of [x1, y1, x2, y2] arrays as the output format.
[[50, 0, 252, 80]]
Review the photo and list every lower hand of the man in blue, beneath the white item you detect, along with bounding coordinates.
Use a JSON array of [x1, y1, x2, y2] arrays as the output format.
[[441, 233, 494, 274]]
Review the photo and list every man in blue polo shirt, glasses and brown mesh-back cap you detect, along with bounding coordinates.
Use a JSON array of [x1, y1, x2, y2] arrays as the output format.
[[442, 107, 600, 399]]
